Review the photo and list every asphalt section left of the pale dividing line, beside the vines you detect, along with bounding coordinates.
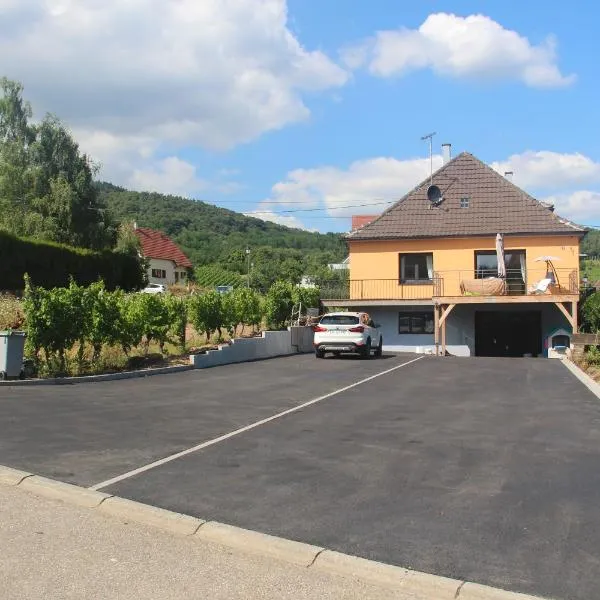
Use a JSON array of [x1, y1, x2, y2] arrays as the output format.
[[0, 355, 404, 486]]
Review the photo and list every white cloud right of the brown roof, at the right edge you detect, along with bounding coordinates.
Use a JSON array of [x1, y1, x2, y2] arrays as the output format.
[[492, 150, 600, 190]]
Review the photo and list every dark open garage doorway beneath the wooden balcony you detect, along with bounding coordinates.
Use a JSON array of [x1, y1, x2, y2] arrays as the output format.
[[475, 310, 542, 357]]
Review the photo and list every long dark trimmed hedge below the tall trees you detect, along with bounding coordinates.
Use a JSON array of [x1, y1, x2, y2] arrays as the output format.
[[0, 232, 146, 291]]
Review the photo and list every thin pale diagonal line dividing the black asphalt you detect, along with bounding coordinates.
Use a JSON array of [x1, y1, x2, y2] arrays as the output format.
[[88, 356, 423, 490]]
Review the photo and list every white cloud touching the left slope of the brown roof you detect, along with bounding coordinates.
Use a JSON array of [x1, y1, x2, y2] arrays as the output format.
[[262, 155, 442, 217]]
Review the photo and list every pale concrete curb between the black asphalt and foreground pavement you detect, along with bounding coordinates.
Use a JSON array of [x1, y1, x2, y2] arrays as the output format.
[[0, 465, 541, 600]]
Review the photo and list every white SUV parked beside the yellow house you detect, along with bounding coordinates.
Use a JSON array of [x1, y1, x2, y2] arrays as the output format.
[[313, 312, 383, 358]]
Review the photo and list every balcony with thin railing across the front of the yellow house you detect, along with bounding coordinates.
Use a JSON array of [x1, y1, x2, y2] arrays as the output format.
[[321, 267, 579, 306]]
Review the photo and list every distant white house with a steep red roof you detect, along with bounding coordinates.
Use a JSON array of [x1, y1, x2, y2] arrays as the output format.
[[135, 225, 192, 285]]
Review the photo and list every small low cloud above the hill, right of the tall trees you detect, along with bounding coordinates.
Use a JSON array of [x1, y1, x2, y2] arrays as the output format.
[[127, 156, 208, 196]]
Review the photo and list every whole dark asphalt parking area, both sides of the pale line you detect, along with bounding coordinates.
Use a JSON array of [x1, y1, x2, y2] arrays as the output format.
[[0, 355, 600, 600]]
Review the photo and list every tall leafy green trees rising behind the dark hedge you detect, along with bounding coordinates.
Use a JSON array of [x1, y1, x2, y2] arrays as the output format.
[[0, 78, 115, 249]]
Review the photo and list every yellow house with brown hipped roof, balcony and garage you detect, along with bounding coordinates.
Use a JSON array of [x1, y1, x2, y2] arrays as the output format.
[[324, 153, 586, 356]]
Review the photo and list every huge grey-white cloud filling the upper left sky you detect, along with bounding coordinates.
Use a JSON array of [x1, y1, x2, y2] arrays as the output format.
[[0, 0, 348, 162]]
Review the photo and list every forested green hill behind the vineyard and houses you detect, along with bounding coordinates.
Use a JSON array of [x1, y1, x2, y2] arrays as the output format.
[[96, 182, 347, 286]]
